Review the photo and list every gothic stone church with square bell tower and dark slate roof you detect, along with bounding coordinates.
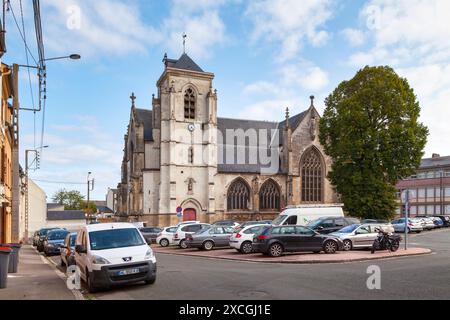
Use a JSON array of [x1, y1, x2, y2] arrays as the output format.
[[117, 54, 336, 225]]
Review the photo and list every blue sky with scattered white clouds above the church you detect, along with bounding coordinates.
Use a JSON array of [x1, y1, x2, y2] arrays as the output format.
[[3, 0, 450, 199]]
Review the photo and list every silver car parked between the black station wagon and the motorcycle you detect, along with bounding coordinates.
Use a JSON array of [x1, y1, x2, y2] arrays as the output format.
[[330, 223, 394, 251]]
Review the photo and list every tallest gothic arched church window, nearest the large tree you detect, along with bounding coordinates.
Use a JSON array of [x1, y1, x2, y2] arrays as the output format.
[[300, 148, 324, 202]]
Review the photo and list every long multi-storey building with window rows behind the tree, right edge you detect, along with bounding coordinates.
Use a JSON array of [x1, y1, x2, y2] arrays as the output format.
[[397, 154, 450, 216]]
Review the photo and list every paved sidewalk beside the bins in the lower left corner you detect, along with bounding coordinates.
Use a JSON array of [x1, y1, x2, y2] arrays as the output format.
[[0, 245, 75, 300]]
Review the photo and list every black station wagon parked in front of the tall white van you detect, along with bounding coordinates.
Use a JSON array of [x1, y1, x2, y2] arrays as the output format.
[[252, 226, 343, 257]]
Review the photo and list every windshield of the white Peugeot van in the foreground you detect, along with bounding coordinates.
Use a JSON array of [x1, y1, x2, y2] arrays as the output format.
[[89, 228, 145, 250]]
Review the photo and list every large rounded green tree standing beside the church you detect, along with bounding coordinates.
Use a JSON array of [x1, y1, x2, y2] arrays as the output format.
[[320, 67, 428, 219]]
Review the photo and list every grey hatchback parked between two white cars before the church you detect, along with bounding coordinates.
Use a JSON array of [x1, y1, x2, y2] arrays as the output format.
[[186, 225, 234, 250]]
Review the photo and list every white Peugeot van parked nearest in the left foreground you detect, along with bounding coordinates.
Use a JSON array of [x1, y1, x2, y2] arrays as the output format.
[[75, 223, 156, 292]]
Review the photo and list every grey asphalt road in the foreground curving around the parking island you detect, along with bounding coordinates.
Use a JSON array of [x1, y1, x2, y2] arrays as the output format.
[[48, 229, 450, 300]]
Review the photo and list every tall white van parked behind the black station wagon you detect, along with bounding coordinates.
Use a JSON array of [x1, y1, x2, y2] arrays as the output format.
[[272, 204, 344, 226]]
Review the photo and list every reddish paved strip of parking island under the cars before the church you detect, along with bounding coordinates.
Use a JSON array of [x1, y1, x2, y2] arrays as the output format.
[[153, 246, 432, 264]]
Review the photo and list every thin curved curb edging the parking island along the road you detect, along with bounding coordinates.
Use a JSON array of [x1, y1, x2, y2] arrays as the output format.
[[156, 249, 433, 264]]
